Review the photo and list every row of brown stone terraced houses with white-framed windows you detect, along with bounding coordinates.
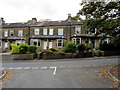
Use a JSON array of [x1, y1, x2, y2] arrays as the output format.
[[0, 17, 105, 52]]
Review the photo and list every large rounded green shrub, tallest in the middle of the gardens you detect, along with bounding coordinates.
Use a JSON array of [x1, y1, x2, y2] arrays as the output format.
[[63, 41, 77, 53]]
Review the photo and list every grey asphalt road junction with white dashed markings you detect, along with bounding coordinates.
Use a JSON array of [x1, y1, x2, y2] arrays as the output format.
[[2, 57, 120, 88]]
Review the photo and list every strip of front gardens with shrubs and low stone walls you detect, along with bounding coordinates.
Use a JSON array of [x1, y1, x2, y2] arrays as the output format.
[[11, 41, 120, 60]]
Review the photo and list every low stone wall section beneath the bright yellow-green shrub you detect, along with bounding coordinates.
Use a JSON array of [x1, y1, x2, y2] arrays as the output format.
[[12, 54, 35, 60]]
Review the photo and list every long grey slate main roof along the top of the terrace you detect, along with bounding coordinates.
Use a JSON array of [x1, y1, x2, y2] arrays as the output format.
[[0, 20, 82, 28]]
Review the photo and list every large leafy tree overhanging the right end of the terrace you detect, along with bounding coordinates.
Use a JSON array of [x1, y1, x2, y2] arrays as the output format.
[[78, 1, 120, 37]]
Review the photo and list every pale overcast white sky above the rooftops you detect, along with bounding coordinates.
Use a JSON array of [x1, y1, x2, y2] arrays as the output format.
[[0, 0, 81, 23]]
